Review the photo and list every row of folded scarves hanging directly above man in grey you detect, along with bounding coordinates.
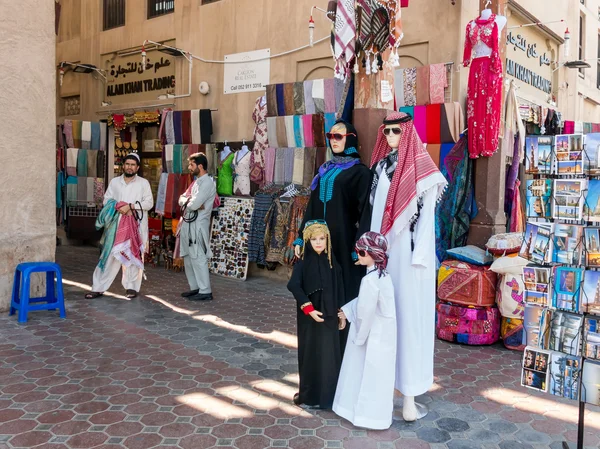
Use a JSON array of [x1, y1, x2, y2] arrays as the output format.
[[160, 109, 213, 145]]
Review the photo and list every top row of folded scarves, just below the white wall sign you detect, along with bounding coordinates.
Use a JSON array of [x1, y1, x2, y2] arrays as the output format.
[[267, 78, 344, 117]]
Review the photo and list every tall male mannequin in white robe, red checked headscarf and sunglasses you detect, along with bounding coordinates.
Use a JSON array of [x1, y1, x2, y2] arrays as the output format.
[[371, 113, 446, 421]]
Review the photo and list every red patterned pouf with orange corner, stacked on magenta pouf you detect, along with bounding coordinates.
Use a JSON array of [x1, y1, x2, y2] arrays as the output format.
[[437, 260, 498, 307]]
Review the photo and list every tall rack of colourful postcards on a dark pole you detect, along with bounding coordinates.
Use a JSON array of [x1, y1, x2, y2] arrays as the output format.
[[520, 134, 600, 449]]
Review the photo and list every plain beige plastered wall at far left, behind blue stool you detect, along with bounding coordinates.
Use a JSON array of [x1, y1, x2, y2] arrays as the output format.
[[0, 0, 56, 311]]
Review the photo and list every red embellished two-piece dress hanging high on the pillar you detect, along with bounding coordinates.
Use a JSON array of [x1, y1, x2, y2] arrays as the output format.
[[463, 14, 502, 159]]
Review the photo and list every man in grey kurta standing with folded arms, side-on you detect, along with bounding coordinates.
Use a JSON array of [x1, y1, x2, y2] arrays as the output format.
[[179, 153, 217, 301]]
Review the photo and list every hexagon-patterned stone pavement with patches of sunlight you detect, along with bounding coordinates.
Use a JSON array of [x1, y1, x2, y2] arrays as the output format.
[[0, 247, 600, 449]]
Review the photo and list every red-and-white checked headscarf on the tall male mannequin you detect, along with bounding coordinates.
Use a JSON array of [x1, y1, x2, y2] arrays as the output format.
[[371, 112, 447, 235]]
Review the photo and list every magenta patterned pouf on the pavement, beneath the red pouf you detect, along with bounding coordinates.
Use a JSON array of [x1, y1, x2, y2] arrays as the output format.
[[436, 303, 500, 345]]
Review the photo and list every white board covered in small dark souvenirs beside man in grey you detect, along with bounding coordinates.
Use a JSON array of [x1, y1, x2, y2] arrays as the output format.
[[209, 198, 254, 280]]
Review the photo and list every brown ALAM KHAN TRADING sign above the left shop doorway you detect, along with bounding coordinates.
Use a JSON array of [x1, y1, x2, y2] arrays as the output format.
[[105, 51, 175, 104]]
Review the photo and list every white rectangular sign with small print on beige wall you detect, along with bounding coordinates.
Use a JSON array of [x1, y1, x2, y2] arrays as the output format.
[[223, 48, 271, 94]]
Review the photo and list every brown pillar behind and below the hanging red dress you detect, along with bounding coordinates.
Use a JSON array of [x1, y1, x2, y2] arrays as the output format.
[[469, 0, 512, 246]]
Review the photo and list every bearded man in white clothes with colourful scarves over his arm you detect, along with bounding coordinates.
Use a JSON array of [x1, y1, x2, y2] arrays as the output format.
[[85, 153, 154, 299]]
